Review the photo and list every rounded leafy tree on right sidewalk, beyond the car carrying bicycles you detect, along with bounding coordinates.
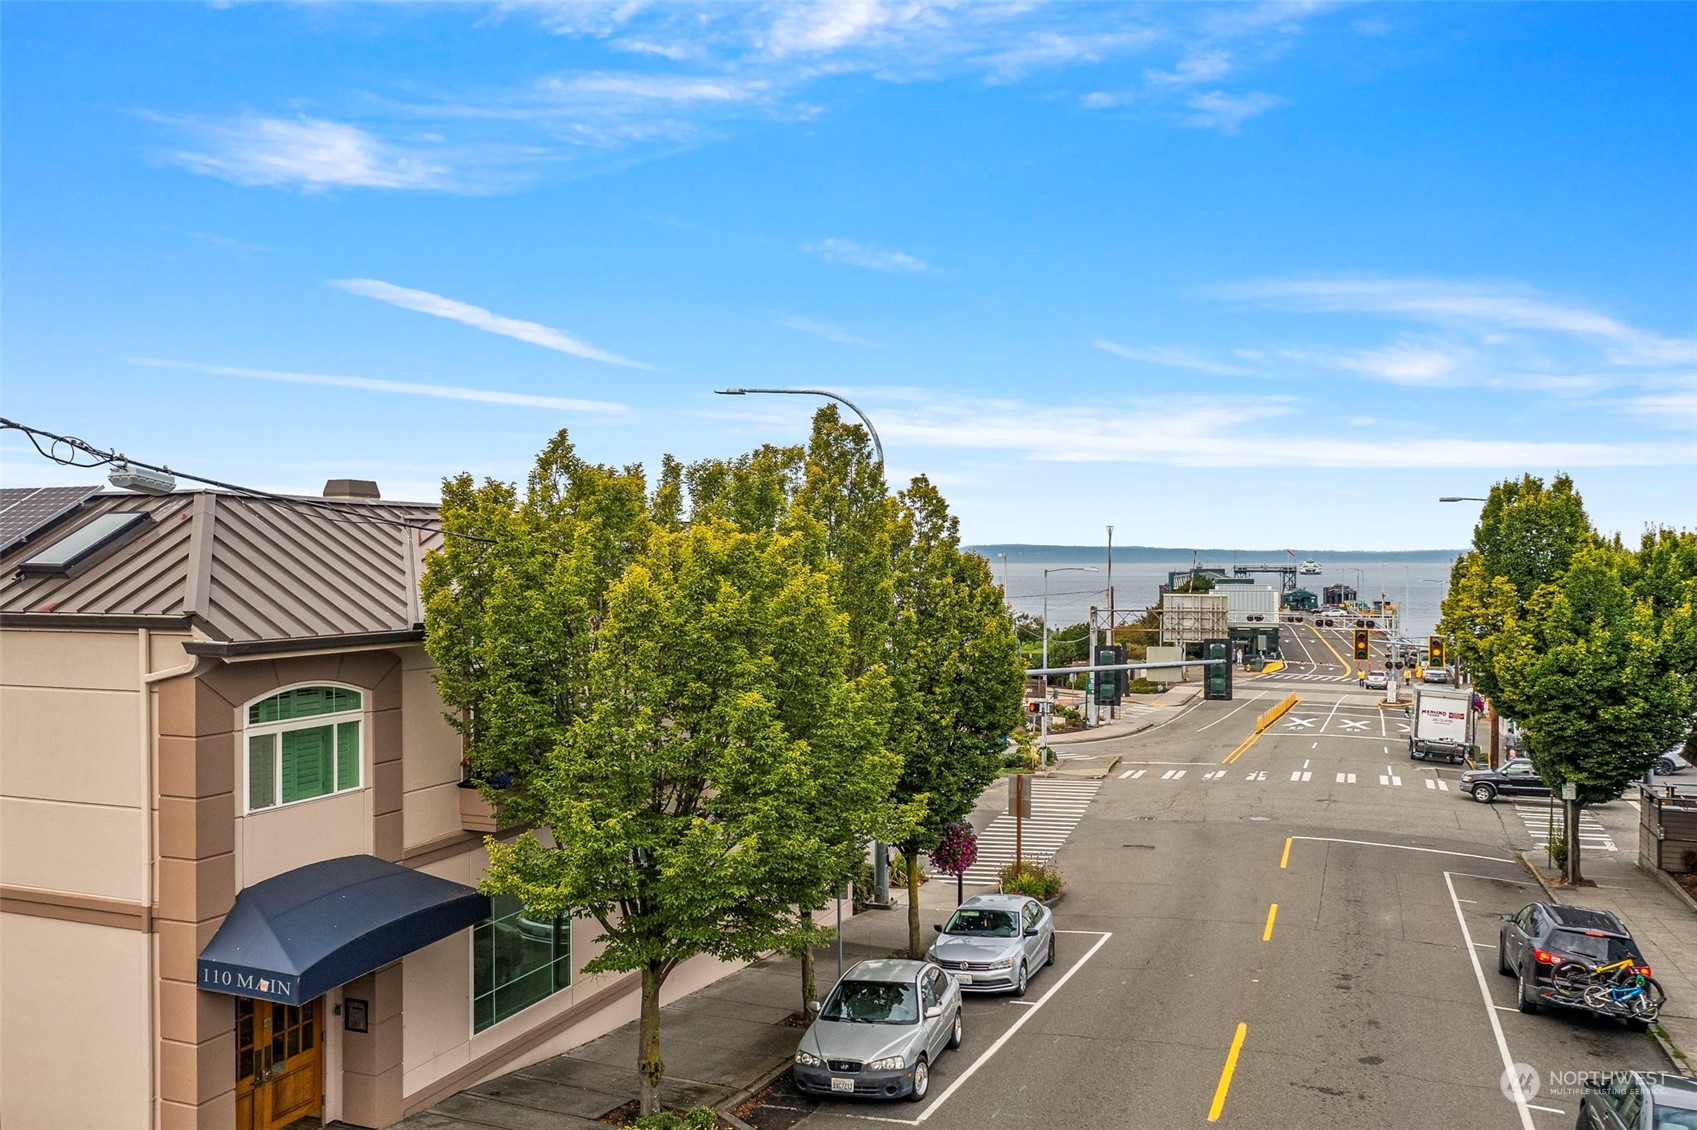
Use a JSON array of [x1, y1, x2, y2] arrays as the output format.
[[1490, 543, 1697, 882]]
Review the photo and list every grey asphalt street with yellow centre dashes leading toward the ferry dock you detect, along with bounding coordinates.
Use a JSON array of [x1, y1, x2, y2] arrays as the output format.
[[760, 629, 1666, 1130]]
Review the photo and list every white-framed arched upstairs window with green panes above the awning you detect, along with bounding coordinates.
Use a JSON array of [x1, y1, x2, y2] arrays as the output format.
[[246, 687, 365, 813]]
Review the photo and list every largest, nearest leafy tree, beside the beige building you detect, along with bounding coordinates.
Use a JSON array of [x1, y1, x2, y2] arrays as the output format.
[[424, 433, 899, 1113]]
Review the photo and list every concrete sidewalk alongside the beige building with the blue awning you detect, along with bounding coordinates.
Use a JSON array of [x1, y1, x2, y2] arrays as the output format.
[[381, 879, 974, 1130]]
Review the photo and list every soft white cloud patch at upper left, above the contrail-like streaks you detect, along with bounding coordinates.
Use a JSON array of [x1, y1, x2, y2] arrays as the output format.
[[170, 114, 458, 192]]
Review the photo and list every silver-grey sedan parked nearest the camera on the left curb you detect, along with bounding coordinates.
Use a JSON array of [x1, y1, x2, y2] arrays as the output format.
[[791, 960, 961, 1103]]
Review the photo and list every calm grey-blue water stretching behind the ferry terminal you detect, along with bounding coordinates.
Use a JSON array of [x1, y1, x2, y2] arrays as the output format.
[[966, 545, 1458, 636]]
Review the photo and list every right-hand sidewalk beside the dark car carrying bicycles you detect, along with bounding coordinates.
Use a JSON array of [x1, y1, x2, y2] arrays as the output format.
[[1522, 850, 1697, 1077]]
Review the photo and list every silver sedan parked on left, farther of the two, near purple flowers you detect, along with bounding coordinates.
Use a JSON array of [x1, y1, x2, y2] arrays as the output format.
[[927, 894, 1056, 996]]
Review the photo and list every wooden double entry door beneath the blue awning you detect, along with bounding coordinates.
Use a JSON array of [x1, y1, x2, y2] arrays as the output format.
[[236, 996, 324, 1130]]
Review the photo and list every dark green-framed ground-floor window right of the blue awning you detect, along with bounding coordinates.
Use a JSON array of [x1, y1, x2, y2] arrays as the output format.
[[472, 894, 572, 1032]]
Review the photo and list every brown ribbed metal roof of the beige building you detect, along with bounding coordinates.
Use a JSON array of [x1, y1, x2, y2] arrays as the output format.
[[0, 490, 441, 645]]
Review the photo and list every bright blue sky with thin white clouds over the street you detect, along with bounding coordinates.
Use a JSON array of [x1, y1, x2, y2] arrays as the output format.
[[0, 0, 1697, 550]]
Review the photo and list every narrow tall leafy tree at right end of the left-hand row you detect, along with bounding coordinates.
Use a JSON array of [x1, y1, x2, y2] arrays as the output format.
[[889, 477, 1023, 957]]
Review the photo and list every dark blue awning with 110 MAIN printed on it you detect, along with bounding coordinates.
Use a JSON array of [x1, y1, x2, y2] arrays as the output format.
[[195, 855, 489, 1004]]
